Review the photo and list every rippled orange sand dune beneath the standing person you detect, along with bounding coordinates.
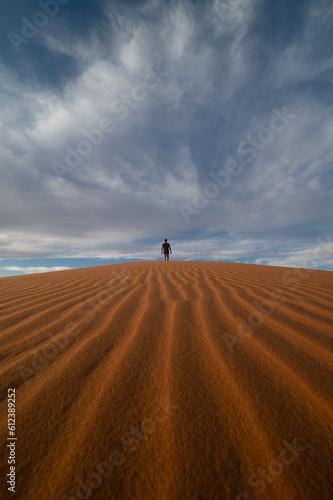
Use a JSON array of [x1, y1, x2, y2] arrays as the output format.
[[0, 261, 333, 500]]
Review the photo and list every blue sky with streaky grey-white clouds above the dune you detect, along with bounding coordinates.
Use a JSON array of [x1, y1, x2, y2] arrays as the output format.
[[0, 0, 333, 276]]
